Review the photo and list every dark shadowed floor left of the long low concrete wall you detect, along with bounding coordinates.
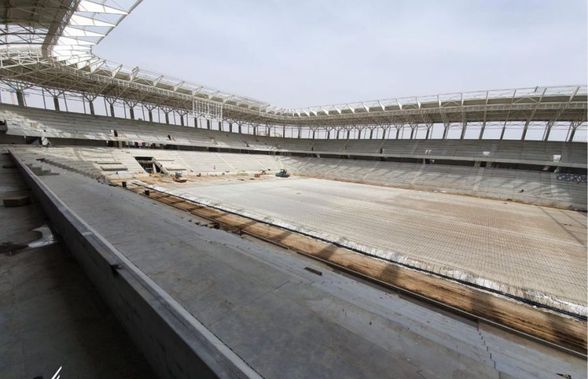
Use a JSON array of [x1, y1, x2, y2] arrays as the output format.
[[0, 151, 154, 379]]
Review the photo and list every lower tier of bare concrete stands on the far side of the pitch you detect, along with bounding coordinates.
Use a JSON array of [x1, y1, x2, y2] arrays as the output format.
[[11, 147, 587, 210]]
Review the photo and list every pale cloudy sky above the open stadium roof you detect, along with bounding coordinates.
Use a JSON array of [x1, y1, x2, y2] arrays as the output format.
[[95, 0, 588, 107]]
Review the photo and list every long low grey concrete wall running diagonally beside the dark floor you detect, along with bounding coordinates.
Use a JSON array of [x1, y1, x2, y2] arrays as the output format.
[[9, 152, 256, 378]]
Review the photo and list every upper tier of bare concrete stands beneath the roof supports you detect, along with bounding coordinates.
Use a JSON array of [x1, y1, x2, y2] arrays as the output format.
[[0, 105, 587, 167]]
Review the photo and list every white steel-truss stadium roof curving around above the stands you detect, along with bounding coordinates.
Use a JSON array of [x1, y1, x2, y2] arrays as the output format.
[[0, 0, 588, 131]]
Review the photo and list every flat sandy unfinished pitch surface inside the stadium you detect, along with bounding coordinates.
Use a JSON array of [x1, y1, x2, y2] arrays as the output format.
[[161, 177, 587, 313]]
